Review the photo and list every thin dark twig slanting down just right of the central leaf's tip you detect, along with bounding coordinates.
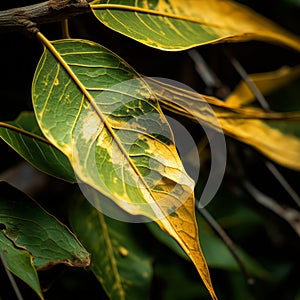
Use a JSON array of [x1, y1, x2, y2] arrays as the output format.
[[196, 203, 255, 286]]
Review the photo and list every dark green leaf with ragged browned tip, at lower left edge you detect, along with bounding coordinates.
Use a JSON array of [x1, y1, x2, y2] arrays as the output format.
[[0, 181, 90, 269]]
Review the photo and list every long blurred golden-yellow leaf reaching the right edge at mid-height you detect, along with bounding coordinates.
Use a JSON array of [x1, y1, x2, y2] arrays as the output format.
[[150, 81, 300, 170]]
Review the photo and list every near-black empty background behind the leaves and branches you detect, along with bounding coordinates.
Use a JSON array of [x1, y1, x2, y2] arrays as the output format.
[[0, 0, 300, 300]]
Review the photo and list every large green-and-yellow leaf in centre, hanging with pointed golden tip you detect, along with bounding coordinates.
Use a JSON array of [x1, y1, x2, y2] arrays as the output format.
[[33, 34, 216, 299]]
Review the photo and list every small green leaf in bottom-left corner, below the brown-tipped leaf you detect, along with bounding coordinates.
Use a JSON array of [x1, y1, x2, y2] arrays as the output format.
[[0, 231, 44, 299]]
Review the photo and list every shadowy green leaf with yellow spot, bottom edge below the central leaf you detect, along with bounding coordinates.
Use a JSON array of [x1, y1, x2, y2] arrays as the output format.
[[70, 192, 152, 300]]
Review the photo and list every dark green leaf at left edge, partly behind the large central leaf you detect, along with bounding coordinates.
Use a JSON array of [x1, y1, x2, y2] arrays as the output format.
[[0, 112, 75, 182]]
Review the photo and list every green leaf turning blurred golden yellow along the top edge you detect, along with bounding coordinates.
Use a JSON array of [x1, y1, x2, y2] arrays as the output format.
[[90, 0, 300, 51]]
